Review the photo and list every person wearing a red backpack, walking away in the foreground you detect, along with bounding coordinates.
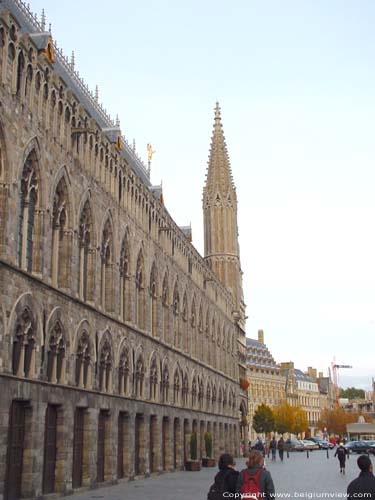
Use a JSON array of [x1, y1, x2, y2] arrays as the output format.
[[236, 450, 275, 500]]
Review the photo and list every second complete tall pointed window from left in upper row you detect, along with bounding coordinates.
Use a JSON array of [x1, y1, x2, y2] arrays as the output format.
[[52, 177, 72, 287]]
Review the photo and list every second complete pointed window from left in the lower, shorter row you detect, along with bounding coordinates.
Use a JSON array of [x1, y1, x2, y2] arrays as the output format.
[[47, 321, 66, 384]]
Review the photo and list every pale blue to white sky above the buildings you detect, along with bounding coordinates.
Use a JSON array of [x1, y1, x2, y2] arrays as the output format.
[[27, 0, 375, 389]]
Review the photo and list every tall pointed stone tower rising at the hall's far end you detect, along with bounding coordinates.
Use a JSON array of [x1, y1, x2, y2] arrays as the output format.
[[203, 102, 245, 329]]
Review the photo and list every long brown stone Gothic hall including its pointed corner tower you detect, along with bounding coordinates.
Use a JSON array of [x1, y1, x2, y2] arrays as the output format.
[[0, 0, 247, 500]]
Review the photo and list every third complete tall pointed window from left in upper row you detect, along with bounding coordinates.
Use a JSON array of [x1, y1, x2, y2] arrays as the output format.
[[79, 200, 93, 300]]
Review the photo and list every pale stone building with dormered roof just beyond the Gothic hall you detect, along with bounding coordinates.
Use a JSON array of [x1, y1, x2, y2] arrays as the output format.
[[246, 330, 286, 441]]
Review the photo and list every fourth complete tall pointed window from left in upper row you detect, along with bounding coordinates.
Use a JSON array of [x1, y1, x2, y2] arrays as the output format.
[[100, 219, 114, 312]]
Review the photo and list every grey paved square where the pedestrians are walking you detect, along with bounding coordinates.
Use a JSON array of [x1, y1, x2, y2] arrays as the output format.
[[71, 450, 374, 500]]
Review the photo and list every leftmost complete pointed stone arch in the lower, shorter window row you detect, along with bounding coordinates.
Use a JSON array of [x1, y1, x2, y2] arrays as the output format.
[[8, 292, 43, 378]]
